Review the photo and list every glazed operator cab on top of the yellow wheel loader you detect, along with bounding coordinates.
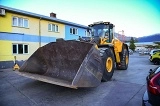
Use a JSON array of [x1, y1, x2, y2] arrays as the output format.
[[88, 22, 114, 43]]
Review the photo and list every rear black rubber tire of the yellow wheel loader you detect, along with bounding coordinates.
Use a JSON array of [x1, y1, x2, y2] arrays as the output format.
[[116, 46, 129, 70]]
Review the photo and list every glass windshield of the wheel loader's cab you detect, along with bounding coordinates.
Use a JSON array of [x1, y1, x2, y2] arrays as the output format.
[[91, 24, 109, 37]]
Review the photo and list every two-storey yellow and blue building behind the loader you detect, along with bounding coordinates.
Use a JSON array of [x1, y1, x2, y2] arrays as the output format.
[[0, 5, 87, 69]]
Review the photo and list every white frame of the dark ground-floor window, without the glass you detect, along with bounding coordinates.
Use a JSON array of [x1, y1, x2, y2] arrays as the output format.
[[12, 43, 29, 55]]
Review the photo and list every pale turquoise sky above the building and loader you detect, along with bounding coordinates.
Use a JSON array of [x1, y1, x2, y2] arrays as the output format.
[[0, 0, 160, 37]]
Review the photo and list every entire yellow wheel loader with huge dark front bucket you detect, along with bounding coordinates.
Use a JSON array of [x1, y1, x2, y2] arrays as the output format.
[[15, 22, 129, 89]]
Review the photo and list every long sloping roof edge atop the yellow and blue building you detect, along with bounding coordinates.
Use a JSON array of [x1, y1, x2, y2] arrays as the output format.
[[0, 5, 88, 28]]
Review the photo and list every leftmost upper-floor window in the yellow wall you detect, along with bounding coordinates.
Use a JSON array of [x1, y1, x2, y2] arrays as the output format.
[[12, 17, 28, 28]]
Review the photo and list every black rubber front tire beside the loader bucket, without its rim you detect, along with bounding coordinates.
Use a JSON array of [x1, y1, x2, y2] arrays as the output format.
[[102, 48, 114, 82]]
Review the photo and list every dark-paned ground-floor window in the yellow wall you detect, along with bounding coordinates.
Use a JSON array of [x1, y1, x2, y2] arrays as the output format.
[[12, 44, 29, 54]]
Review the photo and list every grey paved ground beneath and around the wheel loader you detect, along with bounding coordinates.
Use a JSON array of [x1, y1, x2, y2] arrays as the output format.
[[0, 54, 157, 106]]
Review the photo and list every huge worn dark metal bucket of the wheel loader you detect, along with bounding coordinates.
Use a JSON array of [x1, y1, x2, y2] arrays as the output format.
[[18, 41, 103, 88]]
